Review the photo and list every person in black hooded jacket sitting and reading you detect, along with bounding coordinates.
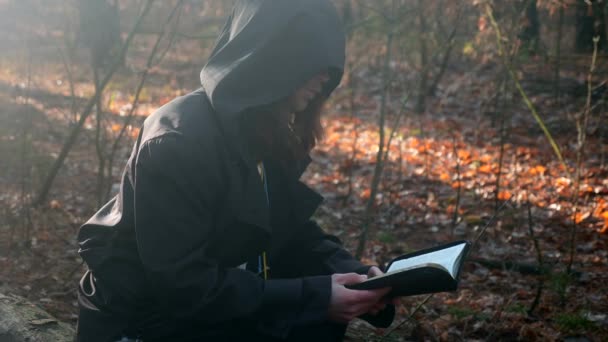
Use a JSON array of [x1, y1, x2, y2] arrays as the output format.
[[76, 0, 394, 342]]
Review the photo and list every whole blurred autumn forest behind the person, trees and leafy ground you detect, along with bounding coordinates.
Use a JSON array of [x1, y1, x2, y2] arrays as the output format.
[[0, 0, 608, 341]]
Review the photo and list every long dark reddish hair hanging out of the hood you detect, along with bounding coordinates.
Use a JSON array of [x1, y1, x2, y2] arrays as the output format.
[[241, 96, 326, 166]]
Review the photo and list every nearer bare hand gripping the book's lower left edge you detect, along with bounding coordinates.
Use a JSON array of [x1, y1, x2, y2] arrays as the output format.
[[328, 273, 390, 323]]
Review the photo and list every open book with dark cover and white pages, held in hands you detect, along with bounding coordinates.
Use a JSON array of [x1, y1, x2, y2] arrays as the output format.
[[346, 240, 470, 297]]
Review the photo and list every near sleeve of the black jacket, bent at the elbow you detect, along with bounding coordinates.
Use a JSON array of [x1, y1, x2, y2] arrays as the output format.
[[134, 136, 331, 337]]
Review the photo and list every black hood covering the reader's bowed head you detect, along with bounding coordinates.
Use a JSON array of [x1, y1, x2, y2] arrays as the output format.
[[201, 0, 345, 116]]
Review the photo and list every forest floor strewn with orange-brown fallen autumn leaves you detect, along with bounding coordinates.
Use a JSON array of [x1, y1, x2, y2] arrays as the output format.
[[0, 28, 608, 341]]
